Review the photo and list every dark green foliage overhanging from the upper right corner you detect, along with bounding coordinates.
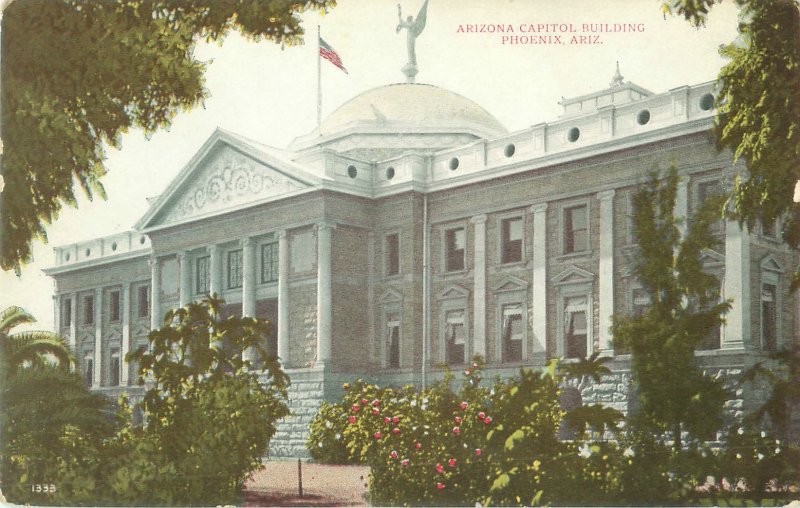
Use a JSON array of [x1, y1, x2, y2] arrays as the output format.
[[662, 0, 800, 284]]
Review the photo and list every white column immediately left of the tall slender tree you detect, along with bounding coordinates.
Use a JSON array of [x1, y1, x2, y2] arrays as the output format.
[[597, 190, 614, 354]]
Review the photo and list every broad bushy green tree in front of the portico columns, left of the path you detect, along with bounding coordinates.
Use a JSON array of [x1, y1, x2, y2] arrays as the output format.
[[122, 298, 289, 505]]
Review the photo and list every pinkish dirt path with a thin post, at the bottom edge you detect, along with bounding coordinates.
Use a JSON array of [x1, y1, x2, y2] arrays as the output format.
[[243, 460, 369, 506]]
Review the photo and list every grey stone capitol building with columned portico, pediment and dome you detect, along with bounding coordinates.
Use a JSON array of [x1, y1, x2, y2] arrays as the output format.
[[46, 26, 800, 456]]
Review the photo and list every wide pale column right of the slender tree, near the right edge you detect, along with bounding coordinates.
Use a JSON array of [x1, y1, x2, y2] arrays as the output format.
[[721, 220, 752, 349]]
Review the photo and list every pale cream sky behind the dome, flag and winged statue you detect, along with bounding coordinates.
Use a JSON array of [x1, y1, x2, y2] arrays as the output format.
[[0, 0, 738, 329]]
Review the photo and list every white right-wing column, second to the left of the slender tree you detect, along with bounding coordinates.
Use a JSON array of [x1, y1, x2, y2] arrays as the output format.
[[531, 203, 547, 355]]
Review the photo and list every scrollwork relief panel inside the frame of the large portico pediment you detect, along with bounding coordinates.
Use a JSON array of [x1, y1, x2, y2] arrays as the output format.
[[160, 146, 308, 226]]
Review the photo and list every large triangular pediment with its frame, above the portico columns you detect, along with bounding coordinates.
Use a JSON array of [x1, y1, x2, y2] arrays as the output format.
[[137, 130, 319, 228]]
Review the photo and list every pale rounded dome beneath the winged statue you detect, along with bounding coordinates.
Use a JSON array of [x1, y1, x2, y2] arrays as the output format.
[[292, 83, 508, 155]]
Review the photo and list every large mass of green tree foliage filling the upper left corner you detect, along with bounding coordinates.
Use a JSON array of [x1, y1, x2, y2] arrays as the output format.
[[0, 0, 335, 273]]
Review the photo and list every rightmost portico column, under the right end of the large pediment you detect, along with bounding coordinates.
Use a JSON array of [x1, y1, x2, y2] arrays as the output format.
[[317, 222, 333, 367]]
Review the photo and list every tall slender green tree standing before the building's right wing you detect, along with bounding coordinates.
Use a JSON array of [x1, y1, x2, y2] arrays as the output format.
[[612, 168, 730, 451]]
